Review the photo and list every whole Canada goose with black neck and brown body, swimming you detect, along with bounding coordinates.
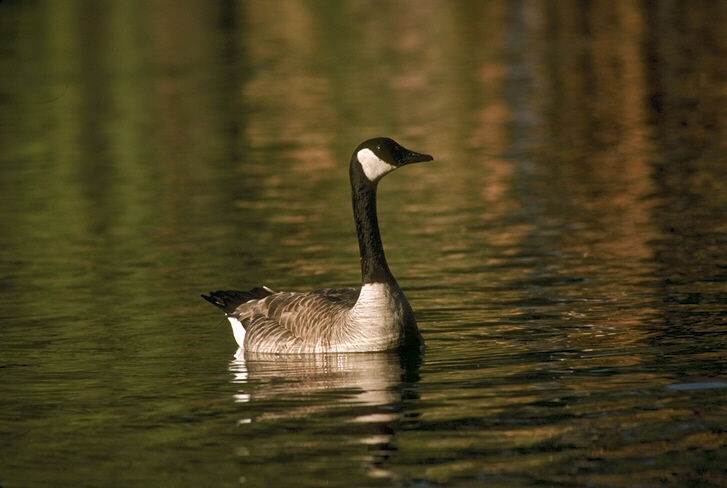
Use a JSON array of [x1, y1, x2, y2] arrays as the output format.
[[202, 137, 434, 354]]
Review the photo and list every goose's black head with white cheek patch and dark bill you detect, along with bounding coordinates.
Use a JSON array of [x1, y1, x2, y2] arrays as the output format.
[[351, 137, 434, 185]]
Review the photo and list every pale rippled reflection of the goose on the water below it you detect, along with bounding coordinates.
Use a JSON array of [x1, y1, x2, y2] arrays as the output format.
[[229, 349, 422, 477]]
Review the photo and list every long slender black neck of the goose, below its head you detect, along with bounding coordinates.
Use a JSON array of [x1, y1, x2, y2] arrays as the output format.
[[351, 175, 396, 284]]
